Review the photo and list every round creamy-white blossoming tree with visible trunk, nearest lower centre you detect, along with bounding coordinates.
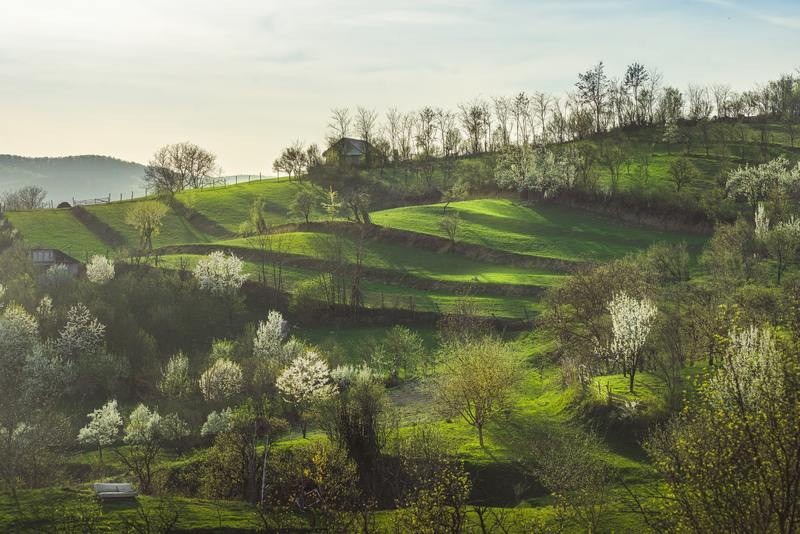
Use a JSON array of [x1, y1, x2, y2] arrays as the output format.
[[277, 351, 336, 438]]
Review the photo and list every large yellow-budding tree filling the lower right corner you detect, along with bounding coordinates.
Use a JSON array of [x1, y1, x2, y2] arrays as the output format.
[[640, 327, 800, 533]]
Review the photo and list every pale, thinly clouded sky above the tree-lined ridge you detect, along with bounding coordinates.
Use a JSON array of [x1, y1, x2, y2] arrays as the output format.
[[0, 0, 800, 174]]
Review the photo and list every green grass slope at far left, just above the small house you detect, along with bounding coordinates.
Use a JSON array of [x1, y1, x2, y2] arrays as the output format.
[[5, 209, 110, 261]]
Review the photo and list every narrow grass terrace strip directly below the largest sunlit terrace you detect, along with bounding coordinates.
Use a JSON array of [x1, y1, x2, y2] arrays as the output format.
[[218, 232, 564, 286]]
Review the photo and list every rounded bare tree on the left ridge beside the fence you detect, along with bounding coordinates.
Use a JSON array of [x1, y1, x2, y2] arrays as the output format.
[[144, 143, 217, 196]]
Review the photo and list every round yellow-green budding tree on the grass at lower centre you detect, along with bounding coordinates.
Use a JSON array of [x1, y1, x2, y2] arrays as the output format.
[[435, 337, 520, 447]]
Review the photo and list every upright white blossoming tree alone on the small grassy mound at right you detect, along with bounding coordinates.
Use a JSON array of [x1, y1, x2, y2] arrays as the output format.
[[607, 292, 658, 393]]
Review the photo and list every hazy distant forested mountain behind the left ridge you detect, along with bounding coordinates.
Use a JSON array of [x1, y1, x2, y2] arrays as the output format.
[[0, 154, 144, 203]]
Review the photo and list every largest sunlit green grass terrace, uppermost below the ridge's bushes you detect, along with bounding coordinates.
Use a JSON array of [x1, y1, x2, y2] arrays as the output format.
[[372, 199, 705, 261]]
